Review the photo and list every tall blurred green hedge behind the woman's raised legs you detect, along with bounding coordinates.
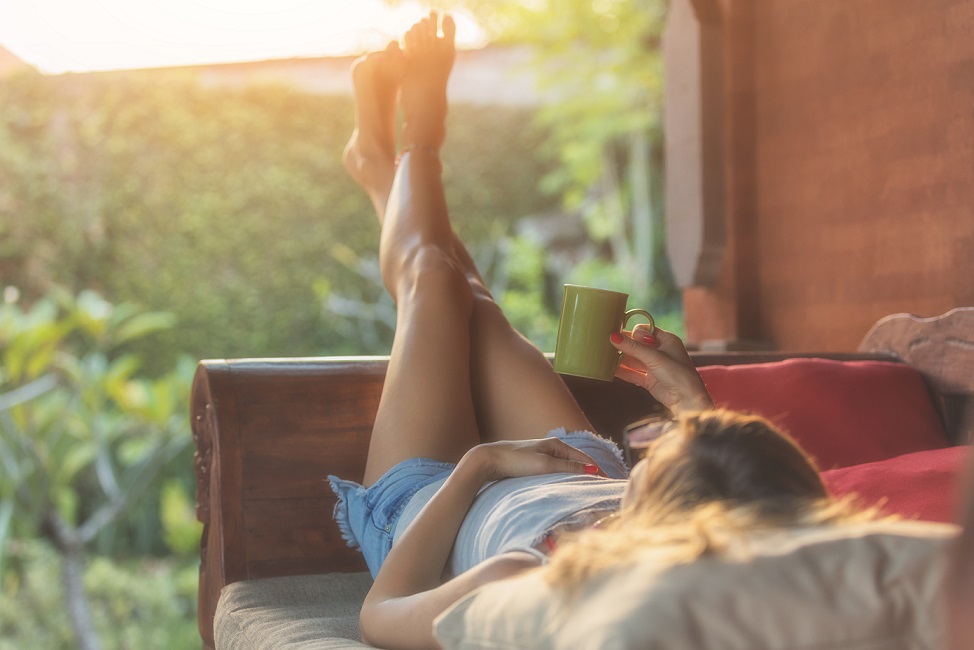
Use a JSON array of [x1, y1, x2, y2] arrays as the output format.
[[0, 71, 554, 364]]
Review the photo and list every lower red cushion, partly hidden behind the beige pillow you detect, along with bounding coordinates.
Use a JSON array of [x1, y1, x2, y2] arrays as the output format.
[[822, 446, 971, 522]]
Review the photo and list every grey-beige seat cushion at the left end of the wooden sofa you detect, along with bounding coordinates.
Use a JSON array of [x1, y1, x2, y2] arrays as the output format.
[[213, 572, 372, 650]]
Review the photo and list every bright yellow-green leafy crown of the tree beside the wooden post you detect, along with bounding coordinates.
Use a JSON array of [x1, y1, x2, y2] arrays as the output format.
[[434, 0, 667, 191]]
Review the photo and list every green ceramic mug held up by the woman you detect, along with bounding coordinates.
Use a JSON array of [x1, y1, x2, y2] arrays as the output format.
[[554, 284, 656, 381]]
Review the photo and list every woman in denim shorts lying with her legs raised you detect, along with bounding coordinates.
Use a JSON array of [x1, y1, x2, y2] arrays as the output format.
[[330, 14, 856, 648]]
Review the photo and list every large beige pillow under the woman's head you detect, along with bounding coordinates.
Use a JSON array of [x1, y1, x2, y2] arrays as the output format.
[[435, 522, 957, 650]]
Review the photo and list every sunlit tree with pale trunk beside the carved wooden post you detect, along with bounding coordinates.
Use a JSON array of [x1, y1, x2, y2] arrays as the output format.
[[410, 0, 675, 308]]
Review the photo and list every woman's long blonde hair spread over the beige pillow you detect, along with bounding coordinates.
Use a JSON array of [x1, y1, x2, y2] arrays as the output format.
[[545, 410, 876, 588]]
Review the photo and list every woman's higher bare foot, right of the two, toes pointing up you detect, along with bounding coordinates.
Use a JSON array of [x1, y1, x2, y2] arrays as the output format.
[[401, 12, 456, 150]]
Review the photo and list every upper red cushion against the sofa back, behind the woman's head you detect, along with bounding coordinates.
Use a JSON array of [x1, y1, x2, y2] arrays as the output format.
[[700, 359, 949, 469]]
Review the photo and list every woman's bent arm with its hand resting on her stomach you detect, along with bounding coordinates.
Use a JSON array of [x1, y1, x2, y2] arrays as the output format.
[[359, 438, 592, 648]]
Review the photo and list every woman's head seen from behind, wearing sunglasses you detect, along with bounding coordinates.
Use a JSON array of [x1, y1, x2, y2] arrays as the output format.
[[624, 410, 827, 517]]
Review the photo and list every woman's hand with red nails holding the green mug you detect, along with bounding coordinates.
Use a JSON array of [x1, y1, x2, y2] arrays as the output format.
[[611, 324, 714, 415]]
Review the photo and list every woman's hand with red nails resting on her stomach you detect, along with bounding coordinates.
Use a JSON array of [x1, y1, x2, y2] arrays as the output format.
[[461, 438, 600, 482]]
